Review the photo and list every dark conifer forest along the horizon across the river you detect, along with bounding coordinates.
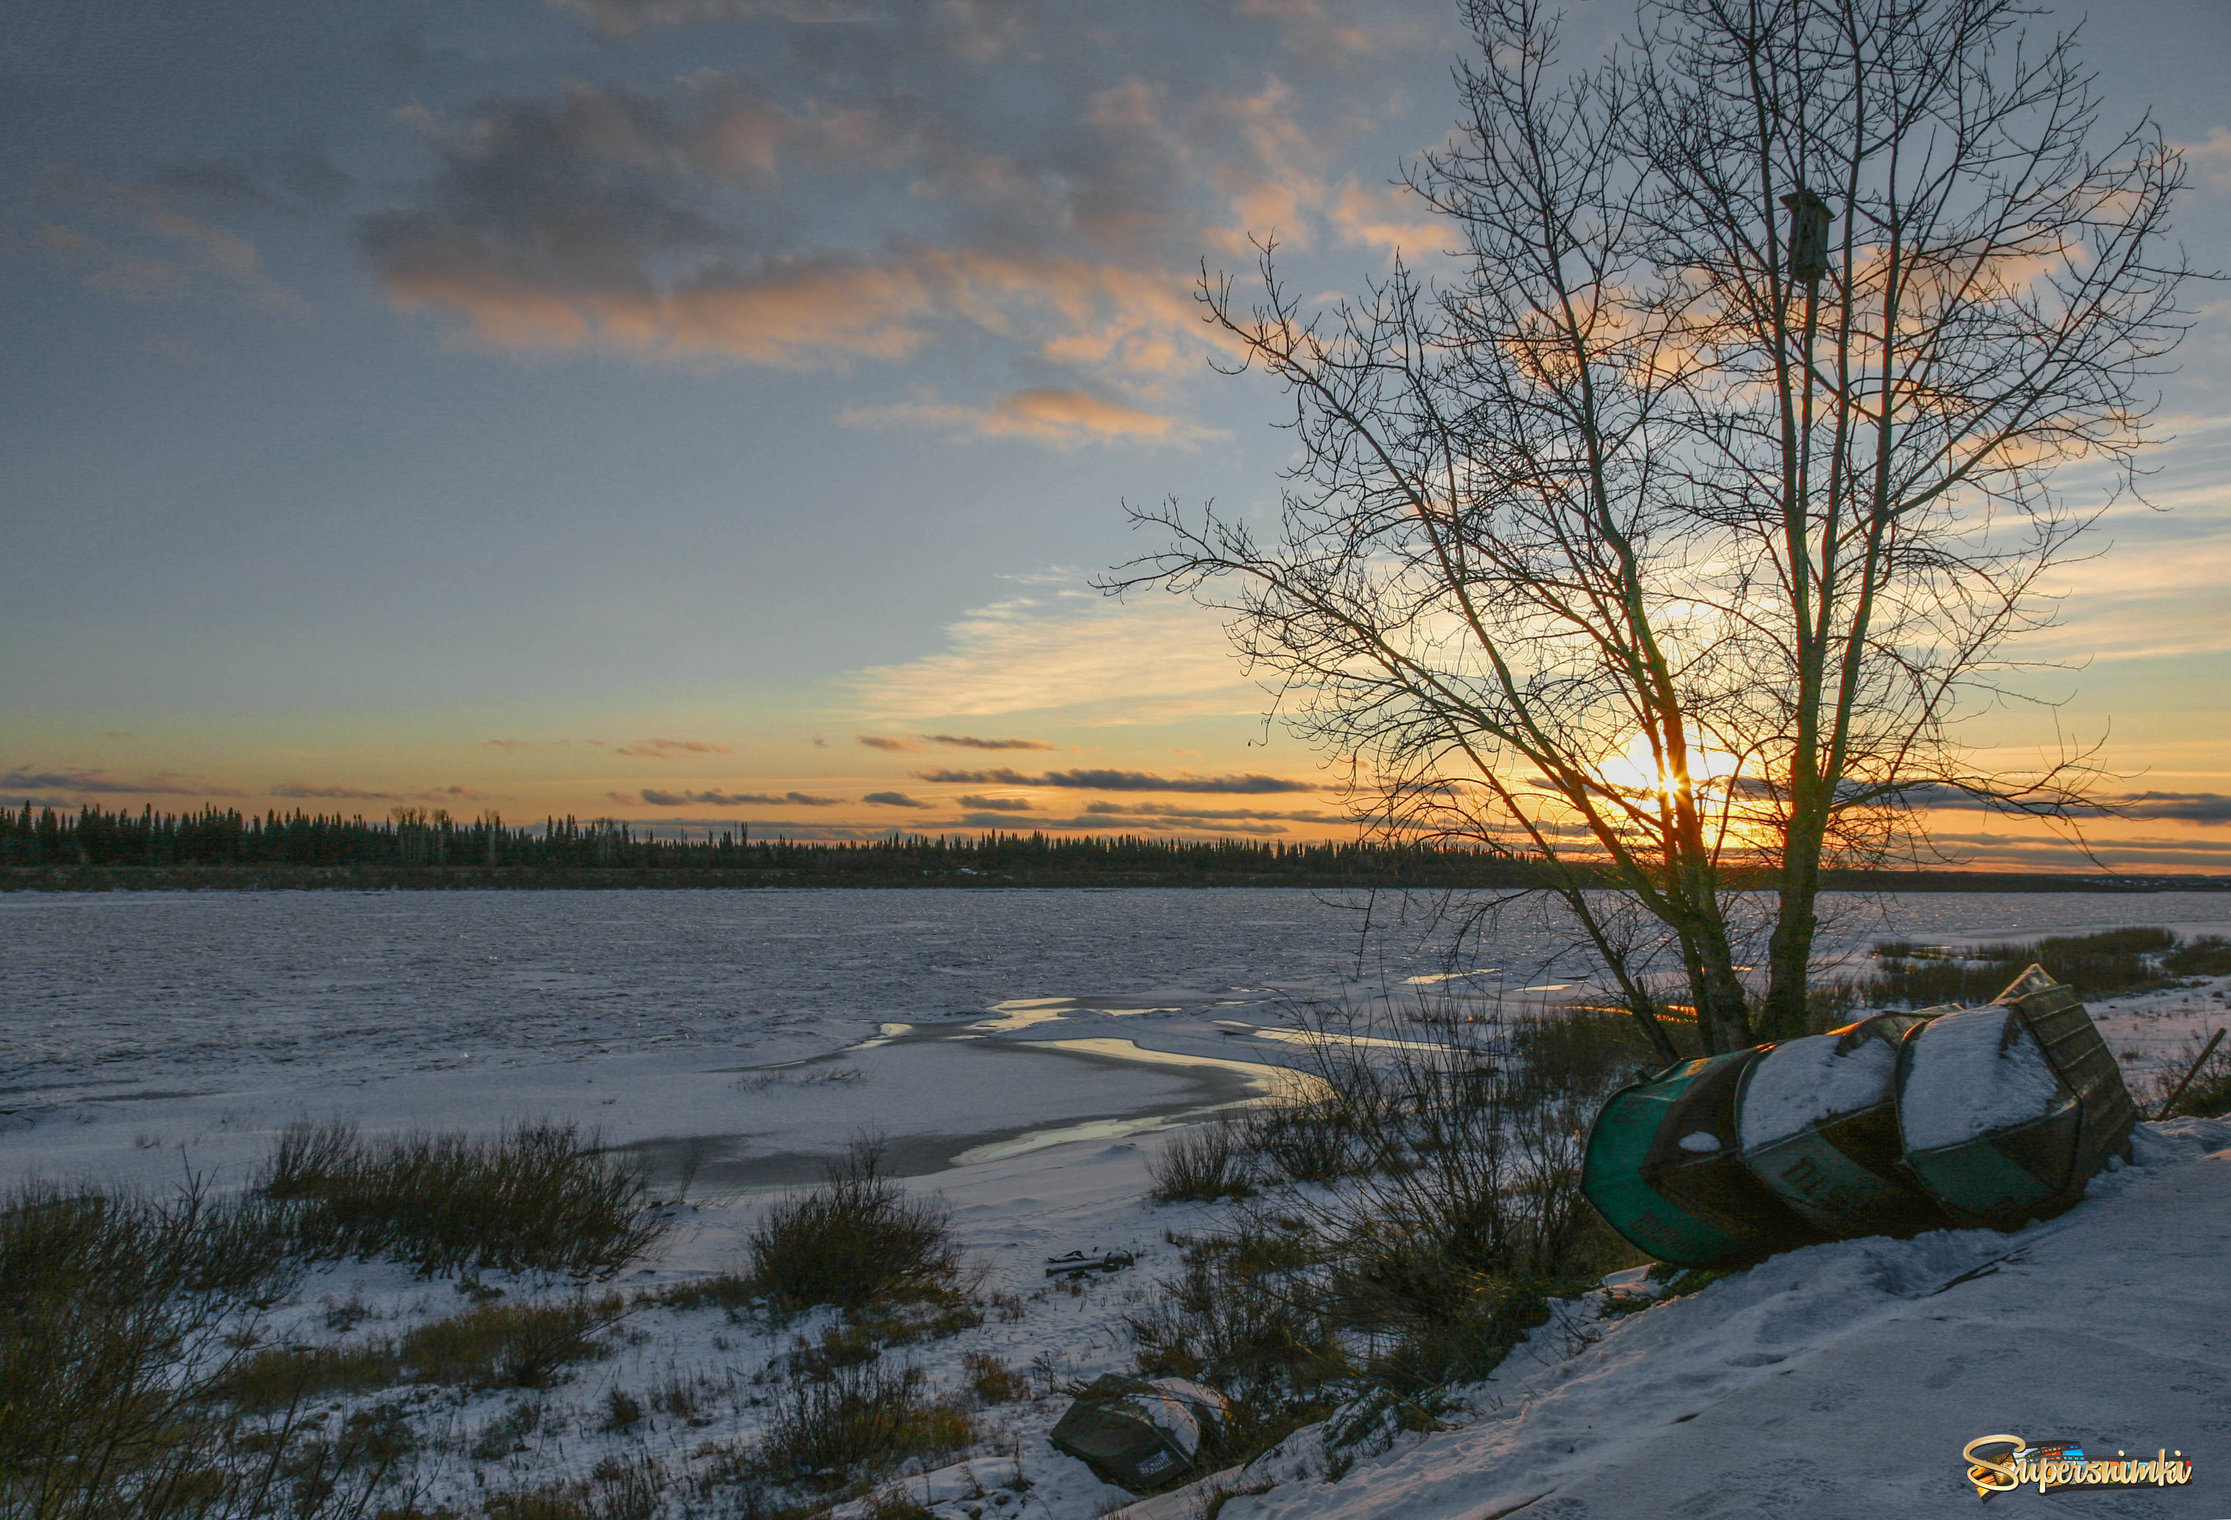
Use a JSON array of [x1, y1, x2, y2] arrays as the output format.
[[0, 804, 2204, 891]]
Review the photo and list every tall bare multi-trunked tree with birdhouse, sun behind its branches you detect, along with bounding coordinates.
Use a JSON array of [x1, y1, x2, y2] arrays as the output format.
[[1107, 0, 2186, 1051]]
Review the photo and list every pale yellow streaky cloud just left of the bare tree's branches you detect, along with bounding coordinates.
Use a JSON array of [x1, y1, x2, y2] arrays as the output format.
[[852, 589, 1265, 723]]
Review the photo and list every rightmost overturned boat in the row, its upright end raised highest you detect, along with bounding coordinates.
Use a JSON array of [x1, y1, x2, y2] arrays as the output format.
[[1899, 966, 2137, 1230]]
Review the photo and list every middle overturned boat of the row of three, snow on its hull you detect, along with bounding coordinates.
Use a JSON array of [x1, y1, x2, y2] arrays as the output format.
[[1736, 1009, 1950, 1239]]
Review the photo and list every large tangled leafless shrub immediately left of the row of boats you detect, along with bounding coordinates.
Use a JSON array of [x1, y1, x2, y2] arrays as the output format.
[[1129, 1009, 1624, 1428]]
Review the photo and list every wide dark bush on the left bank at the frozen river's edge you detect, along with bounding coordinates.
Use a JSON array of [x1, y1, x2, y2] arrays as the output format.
[[257, 1123, 667, 1277]]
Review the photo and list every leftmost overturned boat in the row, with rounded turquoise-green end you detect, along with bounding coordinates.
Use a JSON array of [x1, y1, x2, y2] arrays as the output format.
[[1580, 1047, 1827, 1266]]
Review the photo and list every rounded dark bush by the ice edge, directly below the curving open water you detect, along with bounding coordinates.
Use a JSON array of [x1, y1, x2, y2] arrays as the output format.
[[750, 1141, 959, 1312]]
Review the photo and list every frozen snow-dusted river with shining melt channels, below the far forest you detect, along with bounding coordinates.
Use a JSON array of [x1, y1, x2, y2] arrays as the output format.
[[0, 888, 2231, 1170]]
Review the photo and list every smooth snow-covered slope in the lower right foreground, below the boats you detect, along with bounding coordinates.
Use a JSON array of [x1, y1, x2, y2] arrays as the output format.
[[1124, 1118, 2231, 1520]]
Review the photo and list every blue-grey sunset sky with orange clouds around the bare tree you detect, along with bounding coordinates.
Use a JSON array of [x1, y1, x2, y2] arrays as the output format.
[[0, 0, 2231, 873]]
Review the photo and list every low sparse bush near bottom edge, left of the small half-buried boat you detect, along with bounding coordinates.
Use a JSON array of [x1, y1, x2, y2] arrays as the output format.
[[759, 1362, 975, 1489]]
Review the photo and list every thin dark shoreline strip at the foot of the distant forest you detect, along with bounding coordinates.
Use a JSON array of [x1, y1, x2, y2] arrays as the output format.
[[0, 862, 2231, 895]]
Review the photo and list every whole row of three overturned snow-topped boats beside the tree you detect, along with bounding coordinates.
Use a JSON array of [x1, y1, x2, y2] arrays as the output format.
[[1582, 966, 2137, 1266]]
